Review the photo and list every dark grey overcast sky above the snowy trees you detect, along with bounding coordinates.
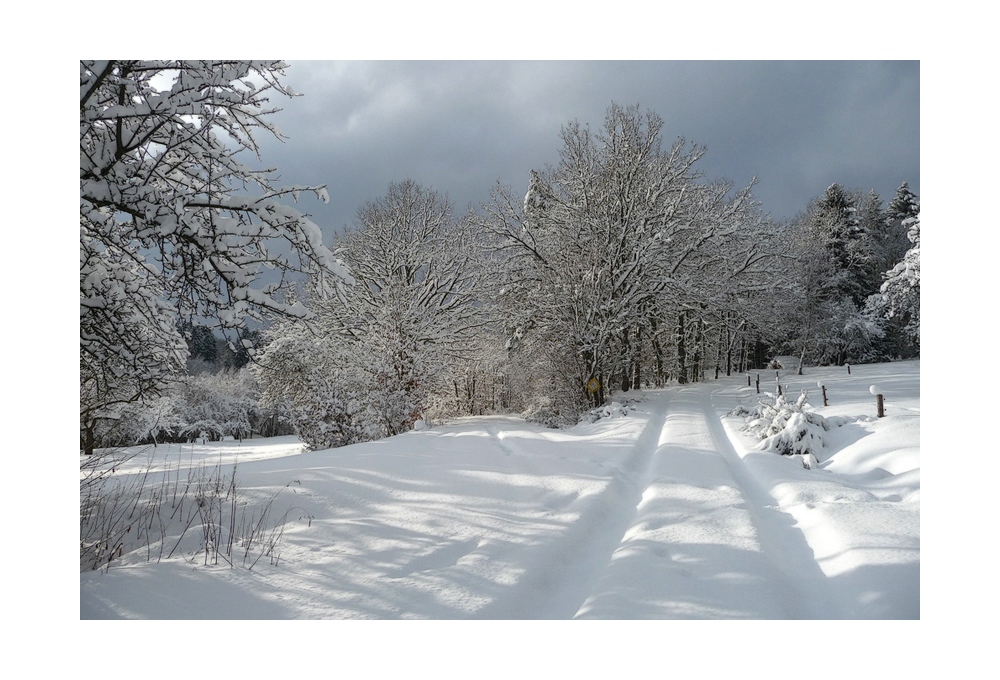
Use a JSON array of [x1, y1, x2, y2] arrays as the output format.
[[254, 61, 920, 242]]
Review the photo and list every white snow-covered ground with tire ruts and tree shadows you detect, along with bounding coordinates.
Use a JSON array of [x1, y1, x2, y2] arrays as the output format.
[[80, 361, 920, 619]]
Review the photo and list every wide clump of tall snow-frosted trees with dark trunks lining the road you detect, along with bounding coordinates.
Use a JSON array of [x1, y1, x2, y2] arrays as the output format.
[[481, 104, 780, 420]]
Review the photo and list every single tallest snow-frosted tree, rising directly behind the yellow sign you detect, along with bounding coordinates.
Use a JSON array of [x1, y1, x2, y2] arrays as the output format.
[[483, 104, 703, 411]]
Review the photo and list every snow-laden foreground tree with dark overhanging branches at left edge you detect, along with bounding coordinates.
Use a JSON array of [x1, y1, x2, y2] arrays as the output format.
[[80, 60, 348, 450]]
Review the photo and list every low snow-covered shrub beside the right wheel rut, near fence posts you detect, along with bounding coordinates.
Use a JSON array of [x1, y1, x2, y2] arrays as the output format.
[[732, 391, 830, 468]]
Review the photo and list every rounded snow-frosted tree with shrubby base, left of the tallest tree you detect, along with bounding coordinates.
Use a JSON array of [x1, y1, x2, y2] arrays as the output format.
[[259, 180, 491, 447]]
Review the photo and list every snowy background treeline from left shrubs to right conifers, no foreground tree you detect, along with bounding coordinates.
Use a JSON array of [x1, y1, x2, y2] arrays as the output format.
[[256, 105, 919, 448]]
